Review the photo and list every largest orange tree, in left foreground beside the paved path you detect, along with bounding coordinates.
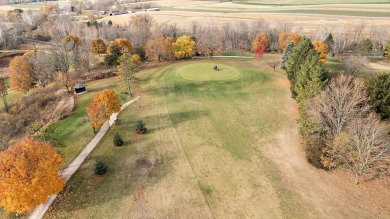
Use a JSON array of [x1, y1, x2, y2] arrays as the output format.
[[0, 138, 65, 213]]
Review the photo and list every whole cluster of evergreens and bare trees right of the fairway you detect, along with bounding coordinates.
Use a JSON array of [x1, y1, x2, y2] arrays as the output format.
[[282, 38, 390, 182]]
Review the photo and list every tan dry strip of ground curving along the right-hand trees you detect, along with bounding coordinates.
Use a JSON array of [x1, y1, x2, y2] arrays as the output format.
[[266, 80, 390, 218]]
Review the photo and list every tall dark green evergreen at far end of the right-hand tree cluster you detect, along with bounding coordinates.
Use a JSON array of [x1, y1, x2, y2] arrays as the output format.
[[285, 39, 315, 98]]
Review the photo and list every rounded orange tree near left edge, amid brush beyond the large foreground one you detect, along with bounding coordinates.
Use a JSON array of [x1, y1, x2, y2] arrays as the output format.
[[8, 56, 34, 93]]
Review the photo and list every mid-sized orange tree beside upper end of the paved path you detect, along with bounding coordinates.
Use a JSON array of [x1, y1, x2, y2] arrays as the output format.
[[87, 89, 121, 133]]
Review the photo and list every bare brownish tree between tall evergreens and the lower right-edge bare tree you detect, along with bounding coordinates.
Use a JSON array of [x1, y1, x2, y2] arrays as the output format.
[[306, 74, 370, 155]]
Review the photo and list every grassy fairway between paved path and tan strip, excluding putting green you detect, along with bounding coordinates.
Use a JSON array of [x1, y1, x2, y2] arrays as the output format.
[[47, 61, 314, 218]]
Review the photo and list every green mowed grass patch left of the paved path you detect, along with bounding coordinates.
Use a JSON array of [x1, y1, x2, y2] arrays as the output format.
[[50, 77, 129, 168]]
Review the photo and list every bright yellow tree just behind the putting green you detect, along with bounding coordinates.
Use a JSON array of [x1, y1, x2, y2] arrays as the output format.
[[172, 35, 195, 59]]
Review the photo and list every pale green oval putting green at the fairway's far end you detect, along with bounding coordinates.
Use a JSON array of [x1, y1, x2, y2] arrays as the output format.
[[176, 63, 241, 81]]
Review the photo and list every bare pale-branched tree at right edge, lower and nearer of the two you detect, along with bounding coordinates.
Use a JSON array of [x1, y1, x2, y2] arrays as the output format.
[[336, 113, 390, 184]]
